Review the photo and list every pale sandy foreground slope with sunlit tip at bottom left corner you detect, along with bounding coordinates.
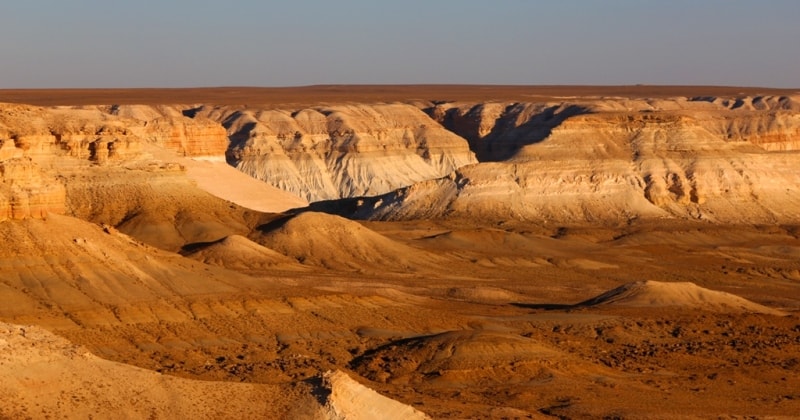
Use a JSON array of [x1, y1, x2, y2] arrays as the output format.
[[0, 322, 438, 420]]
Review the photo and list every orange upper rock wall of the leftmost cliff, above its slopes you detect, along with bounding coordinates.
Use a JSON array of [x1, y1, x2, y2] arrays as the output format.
[[0, 104, 228, 164]]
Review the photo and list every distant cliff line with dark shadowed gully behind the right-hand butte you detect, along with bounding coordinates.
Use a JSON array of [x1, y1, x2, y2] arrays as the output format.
[[425, 96, 800, 162]]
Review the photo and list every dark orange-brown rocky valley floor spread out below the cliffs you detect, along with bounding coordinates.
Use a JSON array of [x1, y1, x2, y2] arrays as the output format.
[[4, 221, 800, 418]]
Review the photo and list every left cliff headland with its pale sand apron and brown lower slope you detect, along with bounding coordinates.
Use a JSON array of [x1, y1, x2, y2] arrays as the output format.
[[0, 104, 305, 250]]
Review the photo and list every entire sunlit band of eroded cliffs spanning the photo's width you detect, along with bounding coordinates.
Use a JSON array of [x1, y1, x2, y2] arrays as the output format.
[[0, 97, 800, 226]]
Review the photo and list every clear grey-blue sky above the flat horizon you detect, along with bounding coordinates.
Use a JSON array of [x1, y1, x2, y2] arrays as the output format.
[[0, 0, 800, 88]]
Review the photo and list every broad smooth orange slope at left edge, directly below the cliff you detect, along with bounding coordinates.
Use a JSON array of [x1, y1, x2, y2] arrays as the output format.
[[0, 215, 268, 326]]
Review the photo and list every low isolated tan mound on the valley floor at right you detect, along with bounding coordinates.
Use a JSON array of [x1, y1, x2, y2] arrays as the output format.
[[577, 280, 786, 315]]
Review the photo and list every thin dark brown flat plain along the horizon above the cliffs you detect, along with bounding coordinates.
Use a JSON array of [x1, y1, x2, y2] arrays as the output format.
[[0, 85, 800, 107]]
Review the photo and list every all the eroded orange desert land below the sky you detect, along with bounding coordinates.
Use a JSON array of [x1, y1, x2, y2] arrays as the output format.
[[0, 86, 800, 419]]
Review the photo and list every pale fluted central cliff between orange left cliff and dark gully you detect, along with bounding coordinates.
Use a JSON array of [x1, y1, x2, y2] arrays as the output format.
[[198, 104, 476, 201]]
